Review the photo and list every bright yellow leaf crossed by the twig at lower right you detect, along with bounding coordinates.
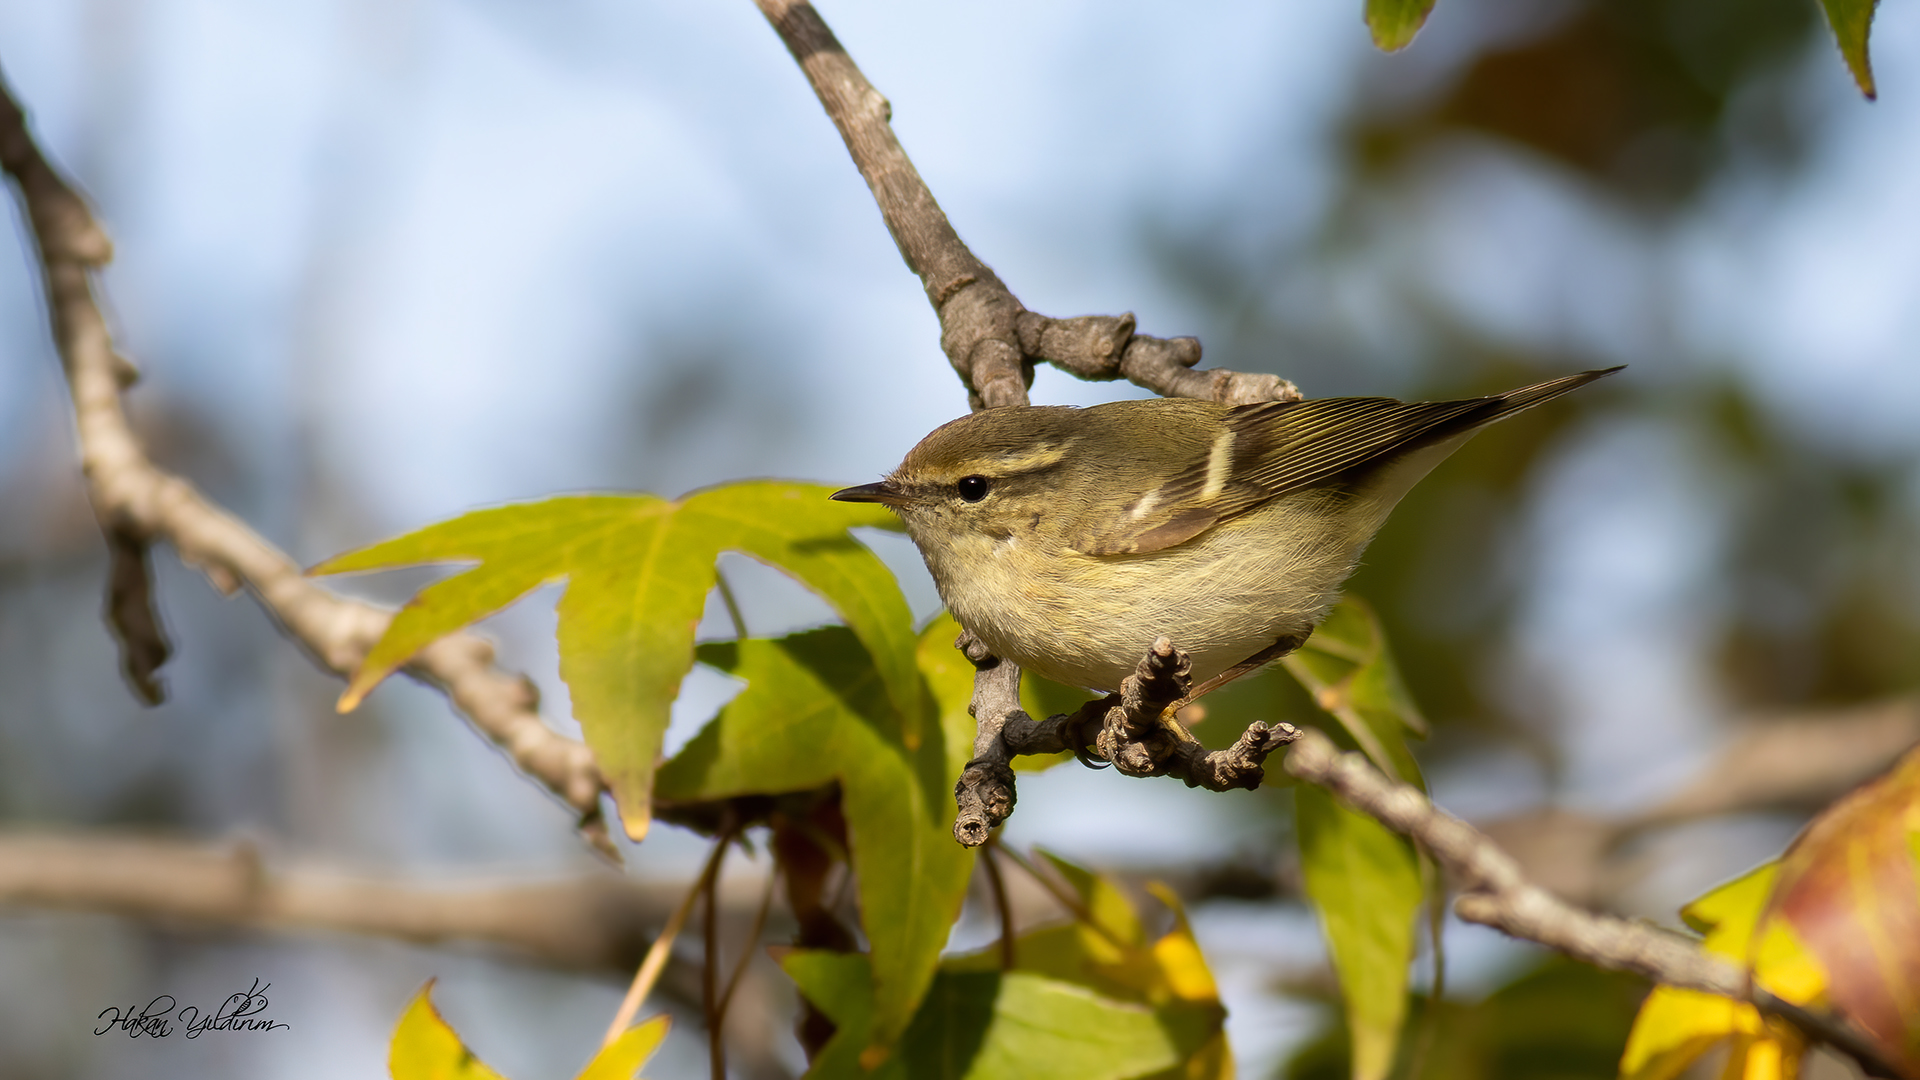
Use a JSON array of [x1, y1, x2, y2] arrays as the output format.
[[1620, 863, 1826, 1080]]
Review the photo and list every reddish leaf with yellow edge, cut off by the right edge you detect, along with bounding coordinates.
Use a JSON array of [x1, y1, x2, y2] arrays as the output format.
[[1761, 734, 1920, 1076]]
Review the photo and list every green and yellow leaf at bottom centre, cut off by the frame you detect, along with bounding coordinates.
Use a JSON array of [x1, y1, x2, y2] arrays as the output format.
[[781, 855, 1233, 1080]]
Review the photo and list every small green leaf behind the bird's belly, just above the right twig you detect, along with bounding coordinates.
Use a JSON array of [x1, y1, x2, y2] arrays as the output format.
[[1281, 598, 1427, 790]]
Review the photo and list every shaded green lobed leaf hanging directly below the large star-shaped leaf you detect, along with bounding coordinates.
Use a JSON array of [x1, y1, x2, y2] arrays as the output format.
[[655, 626, 973, 1045]]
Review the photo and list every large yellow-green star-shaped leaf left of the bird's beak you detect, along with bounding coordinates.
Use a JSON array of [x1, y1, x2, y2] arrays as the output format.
[[309, 480, 922, 840]]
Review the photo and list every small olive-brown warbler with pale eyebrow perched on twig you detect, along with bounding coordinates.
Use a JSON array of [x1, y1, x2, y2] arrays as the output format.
[[833, 367, 1619, 698]]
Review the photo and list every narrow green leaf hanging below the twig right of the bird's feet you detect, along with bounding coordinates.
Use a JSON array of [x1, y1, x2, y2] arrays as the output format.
[[1294, 784, 1421, 1080]]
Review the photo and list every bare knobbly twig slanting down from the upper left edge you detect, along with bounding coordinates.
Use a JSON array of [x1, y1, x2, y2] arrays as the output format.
[[0, 69, 618, 859]]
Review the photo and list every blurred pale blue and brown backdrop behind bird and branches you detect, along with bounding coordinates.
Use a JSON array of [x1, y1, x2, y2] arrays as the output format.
[[0, 0, 1920, 1078]]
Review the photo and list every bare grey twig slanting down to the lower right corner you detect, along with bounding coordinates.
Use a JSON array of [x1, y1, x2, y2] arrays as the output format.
[[1286, 730, 1893, 1076]]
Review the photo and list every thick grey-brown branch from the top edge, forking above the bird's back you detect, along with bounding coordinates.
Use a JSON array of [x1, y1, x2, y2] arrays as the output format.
[[755, 0, 1300, 409]]
